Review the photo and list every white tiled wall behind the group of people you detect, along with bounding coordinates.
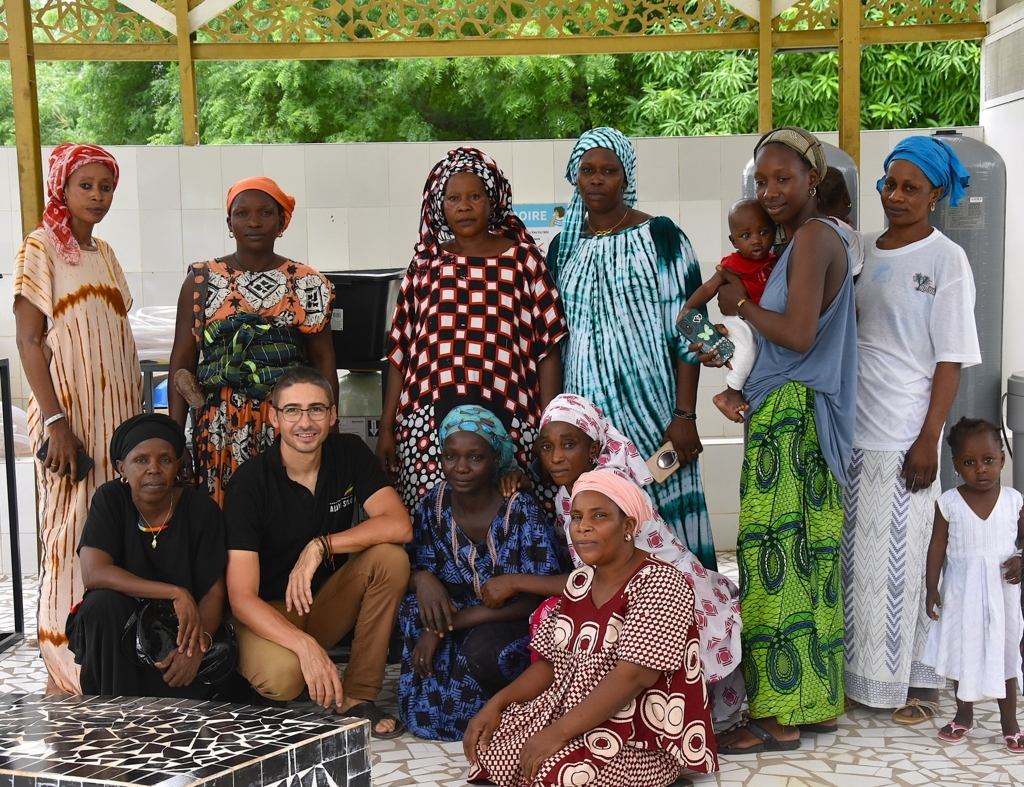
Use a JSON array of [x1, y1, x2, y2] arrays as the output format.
[[0, 128, 987, 545]]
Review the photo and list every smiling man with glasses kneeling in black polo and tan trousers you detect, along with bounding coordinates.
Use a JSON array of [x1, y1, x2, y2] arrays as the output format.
[[224, 367, 413, 738]]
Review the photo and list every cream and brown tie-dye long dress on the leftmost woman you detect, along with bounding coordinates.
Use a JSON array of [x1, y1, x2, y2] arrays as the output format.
[[14, 229, 142, 694]]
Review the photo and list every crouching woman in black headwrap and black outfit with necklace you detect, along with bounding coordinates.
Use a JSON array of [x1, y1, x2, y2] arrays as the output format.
[[67, 413, 227, 699]]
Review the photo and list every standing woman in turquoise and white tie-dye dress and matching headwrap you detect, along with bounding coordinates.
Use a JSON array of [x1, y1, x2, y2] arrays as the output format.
[[548, 128, 717, 569]]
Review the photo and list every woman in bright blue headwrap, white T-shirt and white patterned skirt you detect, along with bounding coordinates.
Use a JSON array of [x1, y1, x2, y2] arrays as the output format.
[[843, 136, 981, 725]]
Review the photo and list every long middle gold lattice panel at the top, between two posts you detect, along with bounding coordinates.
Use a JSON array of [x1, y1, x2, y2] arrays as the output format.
[[197, 0, 754, 43]]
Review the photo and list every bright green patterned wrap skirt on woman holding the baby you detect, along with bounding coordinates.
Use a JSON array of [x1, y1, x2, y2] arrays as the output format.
[[737, 383, 844, 725]]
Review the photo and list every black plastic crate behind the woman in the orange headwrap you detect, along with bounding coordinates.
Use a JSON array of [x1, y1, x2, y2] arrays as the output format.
[[322, 268, 406, 368]]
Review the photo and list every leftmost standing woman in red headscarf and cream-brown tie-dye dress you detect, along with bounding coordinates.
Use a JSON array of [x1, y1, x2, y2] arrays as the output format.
[[14, 142, 142, 694]]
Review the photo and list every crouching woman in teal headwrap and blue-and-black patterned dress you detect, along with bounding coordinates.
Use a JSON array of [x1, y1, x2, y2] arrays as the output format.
[[398, 404, 562, 741]]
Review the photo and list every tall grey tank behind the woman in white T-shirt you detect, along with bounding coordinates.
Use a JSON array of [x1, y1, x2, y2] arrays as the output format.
[[932, 131, 1007, 489]]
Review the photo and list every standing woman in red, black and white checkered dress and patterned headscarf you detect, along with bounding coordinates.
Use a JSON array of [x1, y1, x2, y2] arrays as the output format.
[[377, 147, 567, 511]]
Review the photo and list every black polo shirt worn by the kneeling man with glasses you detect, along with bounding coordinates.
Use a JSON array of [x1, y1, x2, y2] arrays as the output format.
[[224, 434, 390, 601]]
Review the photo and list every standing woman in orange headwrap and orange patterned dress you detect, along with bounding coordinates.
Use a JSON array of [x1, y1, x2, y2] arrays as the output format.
[[168, 177, 338, 506]]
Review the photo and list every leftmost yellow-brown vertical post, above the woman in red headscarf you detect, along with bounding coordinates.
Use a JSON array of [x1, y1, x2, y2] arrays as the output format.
[[4, 0, 43, 235]]
